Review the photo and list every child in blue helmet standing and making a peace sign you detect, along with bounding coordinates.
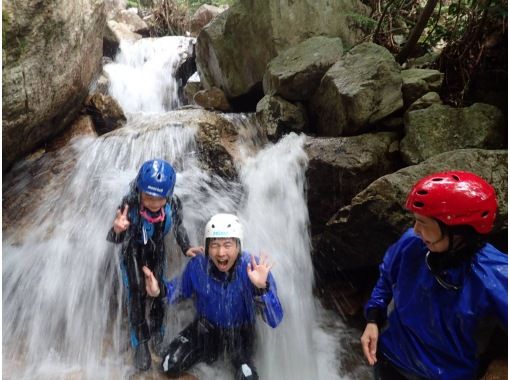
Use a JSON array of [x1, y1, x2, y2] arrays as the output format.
[[107, 159, 203, 371]]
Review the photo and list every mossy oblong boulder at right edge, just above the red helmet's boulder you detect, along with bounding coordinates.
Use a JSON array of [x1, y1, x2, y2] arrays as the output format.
[[400, 103, 506, 165]]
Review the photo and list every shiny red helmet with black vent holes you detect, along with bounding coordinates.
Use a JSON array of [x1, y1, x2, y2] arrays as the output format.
[[406, 171, 498, 234]]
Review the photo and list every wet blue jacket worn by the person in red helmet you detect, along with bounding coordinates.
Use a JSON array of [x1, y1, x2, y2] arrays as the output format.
[[365, 229, 508, 380]]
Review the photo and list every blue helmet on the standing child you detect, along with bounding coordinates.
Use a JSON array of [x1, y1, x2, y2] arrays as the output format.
[[136, 159, 176, 198]]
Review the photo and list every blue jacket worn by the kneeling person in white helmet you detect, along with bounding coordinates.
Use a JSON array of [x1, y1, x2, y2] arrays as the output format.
[[166, 252, 283, 328]]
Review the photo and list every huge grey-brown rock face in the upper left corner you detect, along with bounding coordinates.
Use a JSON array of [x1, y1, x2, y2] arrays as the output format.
[[2, 0, 105, 172]]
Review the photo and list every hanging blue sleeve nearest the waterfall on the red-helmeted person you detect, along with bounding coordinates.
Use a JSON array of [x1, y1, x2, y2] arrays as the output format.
[[365, 233, 402, 326]]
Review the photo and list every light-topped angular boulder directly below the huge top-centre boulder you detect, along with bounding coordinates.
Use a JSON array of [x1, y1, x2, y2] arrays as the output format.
[[263, 36, 343, 100]]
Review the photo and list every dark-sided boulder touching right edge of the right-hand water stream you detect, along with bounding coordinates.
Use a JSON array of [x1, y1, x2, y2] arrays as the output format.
[[305, 132, 399, 234]]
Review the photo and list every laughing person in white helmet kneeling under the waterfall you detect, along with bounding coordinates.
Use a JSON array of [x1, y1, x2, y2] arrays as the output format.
[[143, 214, 283, 380]]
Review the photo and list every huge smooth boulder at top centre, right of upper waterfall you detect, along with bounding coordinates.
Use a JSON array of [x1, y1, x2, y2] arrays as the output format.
[[197, 0, 367, 98]]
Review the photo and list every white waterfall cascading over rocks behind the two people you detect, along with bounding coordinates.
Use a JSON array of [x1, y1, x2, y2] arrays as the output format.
[[3, 37, 366, 380]]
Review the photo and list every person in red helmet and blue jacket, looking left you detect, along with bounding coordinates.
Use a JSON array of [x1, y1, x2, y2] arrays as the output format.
[[361, 171, 508, 380]]
